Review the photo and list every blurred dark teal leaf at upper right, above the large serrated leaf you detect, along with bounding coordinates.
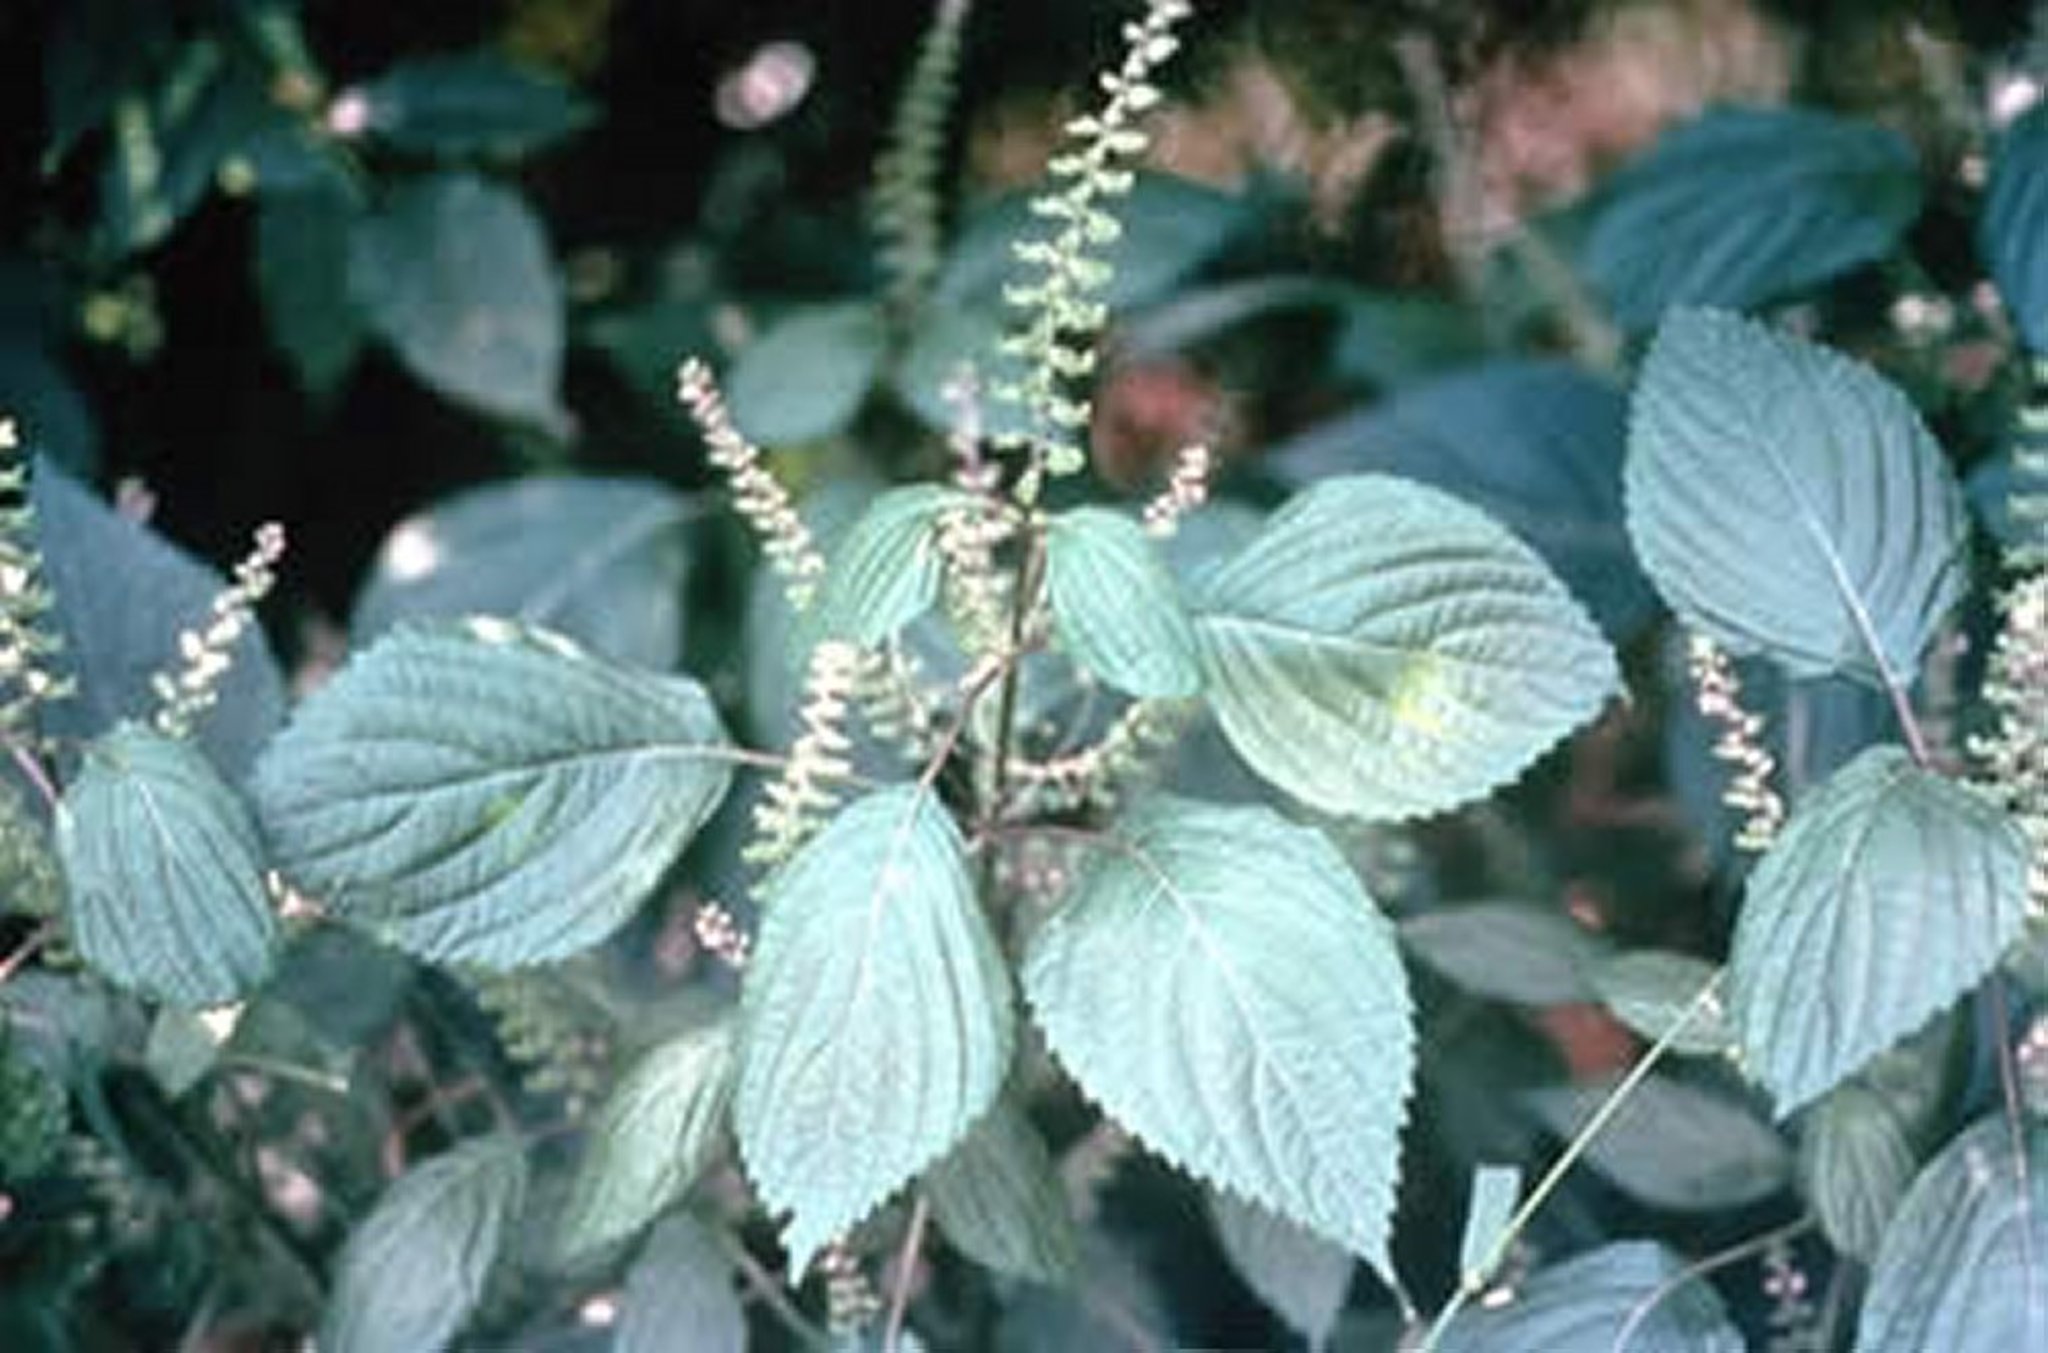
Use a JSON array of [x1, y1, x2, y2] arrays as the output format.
[[1579, 106, 1921, 330]]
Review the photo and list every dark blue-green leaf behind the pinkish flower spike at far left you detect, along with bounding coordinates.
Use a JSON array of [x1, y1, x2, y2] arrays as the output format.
[[31, 461, 285, 780]]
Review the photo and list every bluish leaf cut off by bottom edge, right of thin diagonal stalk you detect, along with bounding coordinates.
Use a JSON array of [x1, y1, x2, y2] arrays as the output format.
[[1442, 1240, 1745, 1353]]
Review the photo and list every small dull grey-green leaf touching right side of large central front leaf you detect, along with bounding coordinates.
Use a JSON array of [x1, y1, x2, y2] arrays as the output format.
[[1401, 903, 1606, 1005]]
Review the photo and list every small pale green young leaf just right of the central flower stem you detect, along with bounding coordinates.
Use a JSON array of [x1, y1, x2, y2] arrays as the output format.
[[1044, 508, 1202, 698]]
